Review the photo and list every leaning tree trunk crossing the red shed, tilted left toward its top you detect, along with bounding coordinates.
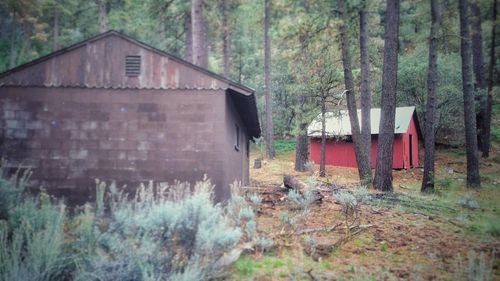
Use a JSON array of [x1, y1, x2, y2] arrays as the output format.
[[338, 0, 372, 185]]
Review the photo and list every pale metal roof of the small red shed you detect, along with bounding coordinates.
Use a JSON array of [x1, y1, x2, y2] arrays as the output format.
[[307, 106, 415, 137]]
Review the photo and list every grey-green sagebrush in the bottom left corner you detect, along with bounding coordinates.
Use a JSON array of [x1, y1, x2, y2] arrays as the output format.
[[0, 195, 71, 281]]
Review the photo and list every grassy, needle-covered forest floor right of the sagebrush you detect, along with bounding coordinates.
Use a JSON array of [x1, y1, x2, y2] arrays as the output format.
[[230, 144, 500, 280]]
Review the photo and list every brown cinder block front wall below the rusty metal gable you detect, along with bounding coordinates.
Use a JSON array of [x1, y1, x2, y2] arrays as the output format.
[[0, 87, 230, 203]]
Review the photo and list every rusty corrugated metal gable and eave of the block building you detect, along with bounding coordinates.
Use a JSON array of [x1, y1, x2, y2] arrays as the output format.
[[0, 30, 261, 137]]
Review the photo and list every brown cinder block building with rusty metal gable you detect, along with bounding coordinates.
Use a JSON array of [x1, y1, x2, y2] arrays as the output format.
[[0, 31, 261, 203]]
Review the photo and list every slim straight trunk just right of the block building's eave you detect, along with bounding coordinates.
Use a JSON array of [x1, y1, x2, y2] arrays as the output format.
[[264, 0, 276, 159]]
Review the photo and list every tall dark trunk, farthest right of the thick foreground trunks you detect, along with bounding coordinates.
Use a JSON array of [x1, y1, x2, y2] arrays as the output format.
[[458, 0, 481, 188]]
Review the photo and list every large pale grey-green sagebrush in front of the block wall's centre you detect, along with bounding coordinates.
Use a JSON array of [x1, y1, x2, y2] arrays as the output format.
[[75, 179, 244, 280]]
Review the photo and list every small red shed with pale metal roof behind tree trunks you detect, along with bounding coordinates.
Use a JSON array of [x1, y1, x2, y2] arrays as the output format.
[[307, 106, 421, 169]]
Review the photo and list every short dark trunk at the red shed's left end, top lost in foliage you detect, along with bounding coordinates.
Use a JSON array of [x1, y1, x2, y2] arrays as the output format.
[[295, 96, 309, 172]]
